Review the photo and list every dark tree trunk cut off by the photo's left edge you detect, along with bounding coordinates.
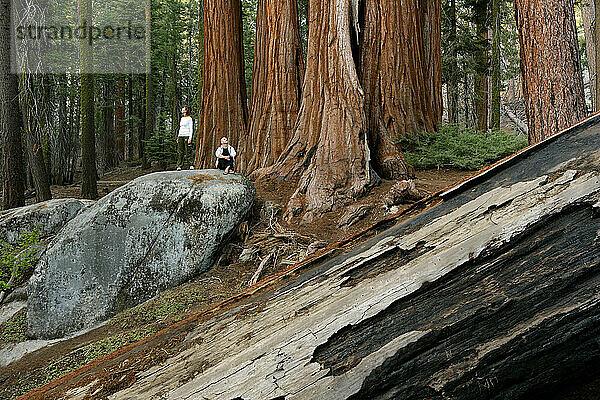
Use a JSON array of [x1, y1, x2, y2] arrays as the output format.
[[0, 0, 25, 209]]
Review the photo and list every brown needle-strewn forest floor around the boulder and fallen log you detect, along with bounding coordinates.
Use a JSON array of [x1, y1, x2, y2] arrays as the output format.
[[0, 167, 474, 399]]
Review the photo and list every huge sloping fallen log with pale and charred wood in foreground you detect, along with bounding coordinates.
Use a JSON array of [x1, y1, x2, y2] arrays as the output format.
[[17, 117, 600, 400]]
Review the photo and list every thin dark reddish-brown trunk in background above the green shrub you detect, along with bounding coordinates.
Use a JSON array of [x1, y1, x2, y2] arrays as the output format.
[[473, 0, 490, 132]]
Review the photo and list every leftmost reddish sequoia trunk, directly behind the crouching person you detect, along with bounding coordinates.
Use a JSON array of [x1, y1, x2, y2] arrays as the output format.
[[195, 0, 248, 168]]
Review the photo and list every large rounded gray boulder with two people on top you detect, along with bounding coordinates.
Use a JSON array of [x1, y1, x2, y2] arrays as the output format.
[[27, 170, 255, 339]]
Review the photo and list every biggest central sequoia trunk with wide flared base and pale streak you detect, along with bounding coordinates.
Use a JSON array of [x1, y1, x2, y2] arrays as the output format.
[[267, 0, 371, 221]]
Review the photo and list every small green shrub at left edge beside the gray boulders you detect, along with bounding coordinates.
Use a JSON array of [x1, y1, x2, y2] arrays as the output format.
[[0, 229, 40, 291]]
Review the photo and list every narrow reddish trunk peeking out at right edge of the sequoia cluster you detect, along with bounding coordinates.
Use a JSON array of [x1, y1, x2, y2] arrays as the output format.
[[420, 0, 444, 124]]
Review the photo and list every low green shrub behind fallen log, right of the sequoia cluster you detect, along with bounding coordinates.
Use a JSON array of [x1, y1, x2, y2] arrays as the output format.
[[398, 125, 527, 170]]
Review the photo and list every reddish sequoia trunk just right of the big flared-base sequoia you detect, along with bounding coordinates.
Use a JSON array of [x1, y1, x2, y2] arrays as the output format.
[[360, 0, 434, 179]]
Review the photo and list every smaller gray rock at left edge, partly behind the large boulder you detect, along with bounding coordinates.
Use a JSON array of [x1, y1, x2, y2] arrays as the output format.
[[0, 199, 95, 244]]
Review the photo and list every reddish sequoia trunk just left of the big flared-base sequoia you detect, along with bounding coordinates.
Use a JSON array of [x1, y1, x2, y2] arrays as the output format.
[[240, 0, 304, 172]]
